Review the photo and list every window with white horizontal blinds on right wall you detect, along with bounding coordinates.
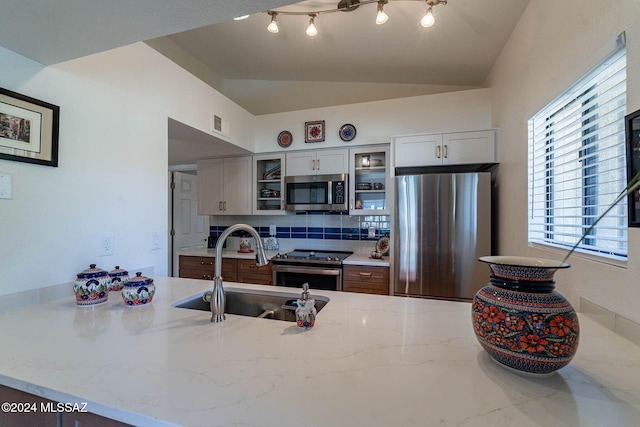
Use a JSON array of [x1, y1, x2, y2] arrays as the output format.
[[528, 47, 627, 260]]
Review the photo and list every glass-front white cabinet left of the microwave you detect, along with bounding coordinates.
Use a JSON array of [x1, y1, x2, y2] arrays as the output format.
[[252, 153, 286, 215]]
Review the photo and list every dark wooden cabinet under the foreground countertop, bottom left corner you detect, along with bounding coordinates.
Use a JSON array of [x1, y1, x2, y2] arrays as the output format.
[[0, 385, 131, 427]]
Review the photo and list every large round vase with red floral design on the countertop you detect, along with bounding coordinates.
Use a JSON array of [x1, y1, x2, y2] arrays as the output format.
[[472, 256, 580, 374]]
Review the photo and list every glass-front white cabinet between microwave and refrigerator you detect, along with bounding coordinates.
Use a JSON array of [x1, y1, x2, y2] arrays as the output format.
[[349, 144, 392, 215]]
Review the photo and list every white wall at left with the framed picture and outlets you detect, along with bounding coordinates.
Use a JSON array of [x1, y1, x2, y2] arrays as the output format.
[[0, 43, 254, 295]]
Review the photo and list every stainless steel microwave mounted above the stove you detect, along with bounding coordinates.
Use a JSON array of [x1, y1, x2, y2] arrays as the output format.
[[284, 173, 349, 211]]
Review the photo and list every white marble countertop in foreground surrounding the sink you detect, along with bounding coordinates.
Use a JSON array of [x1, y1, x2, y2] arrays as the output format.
[[0, 278, 640, 427]]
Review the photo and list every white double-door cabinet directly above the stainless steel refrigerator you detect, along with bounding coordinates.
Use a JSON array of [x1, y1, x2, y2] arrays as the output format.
[[392, 129, 497, 167]]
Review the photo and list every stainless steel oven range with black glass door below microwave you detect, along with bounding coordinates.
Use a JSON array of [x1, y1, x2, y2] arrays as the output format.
[[271, 249, 353, 291]]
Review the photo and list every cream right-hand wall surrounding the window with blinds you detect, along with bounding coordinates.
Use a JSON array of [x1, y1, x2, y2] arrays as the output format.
[[489, 0, 640, 322]]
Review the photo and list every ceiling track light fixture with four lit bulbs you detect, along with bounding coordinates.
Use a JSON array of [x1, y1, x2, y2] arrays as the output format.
[[264, 0, 447, 37]]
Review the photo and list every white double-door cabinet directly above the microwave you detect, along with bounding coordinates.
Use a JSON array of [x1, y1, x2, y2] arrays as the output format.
[[286, 149, 349, 176]]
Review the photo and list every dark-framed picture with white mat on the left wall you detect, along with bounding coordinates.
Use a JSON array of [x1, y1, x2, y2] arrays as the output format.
[[0, 88, 60, 167]]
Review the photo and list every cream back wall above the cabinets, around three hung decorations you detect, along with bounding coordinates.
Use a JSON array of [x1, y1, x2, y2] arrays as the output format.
[[255, 89, 491, 153]]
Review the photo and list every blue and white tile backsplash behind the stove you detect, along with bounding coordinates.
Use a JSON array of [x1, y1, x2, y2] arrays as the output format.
[[209, 213, 390, 241]]
